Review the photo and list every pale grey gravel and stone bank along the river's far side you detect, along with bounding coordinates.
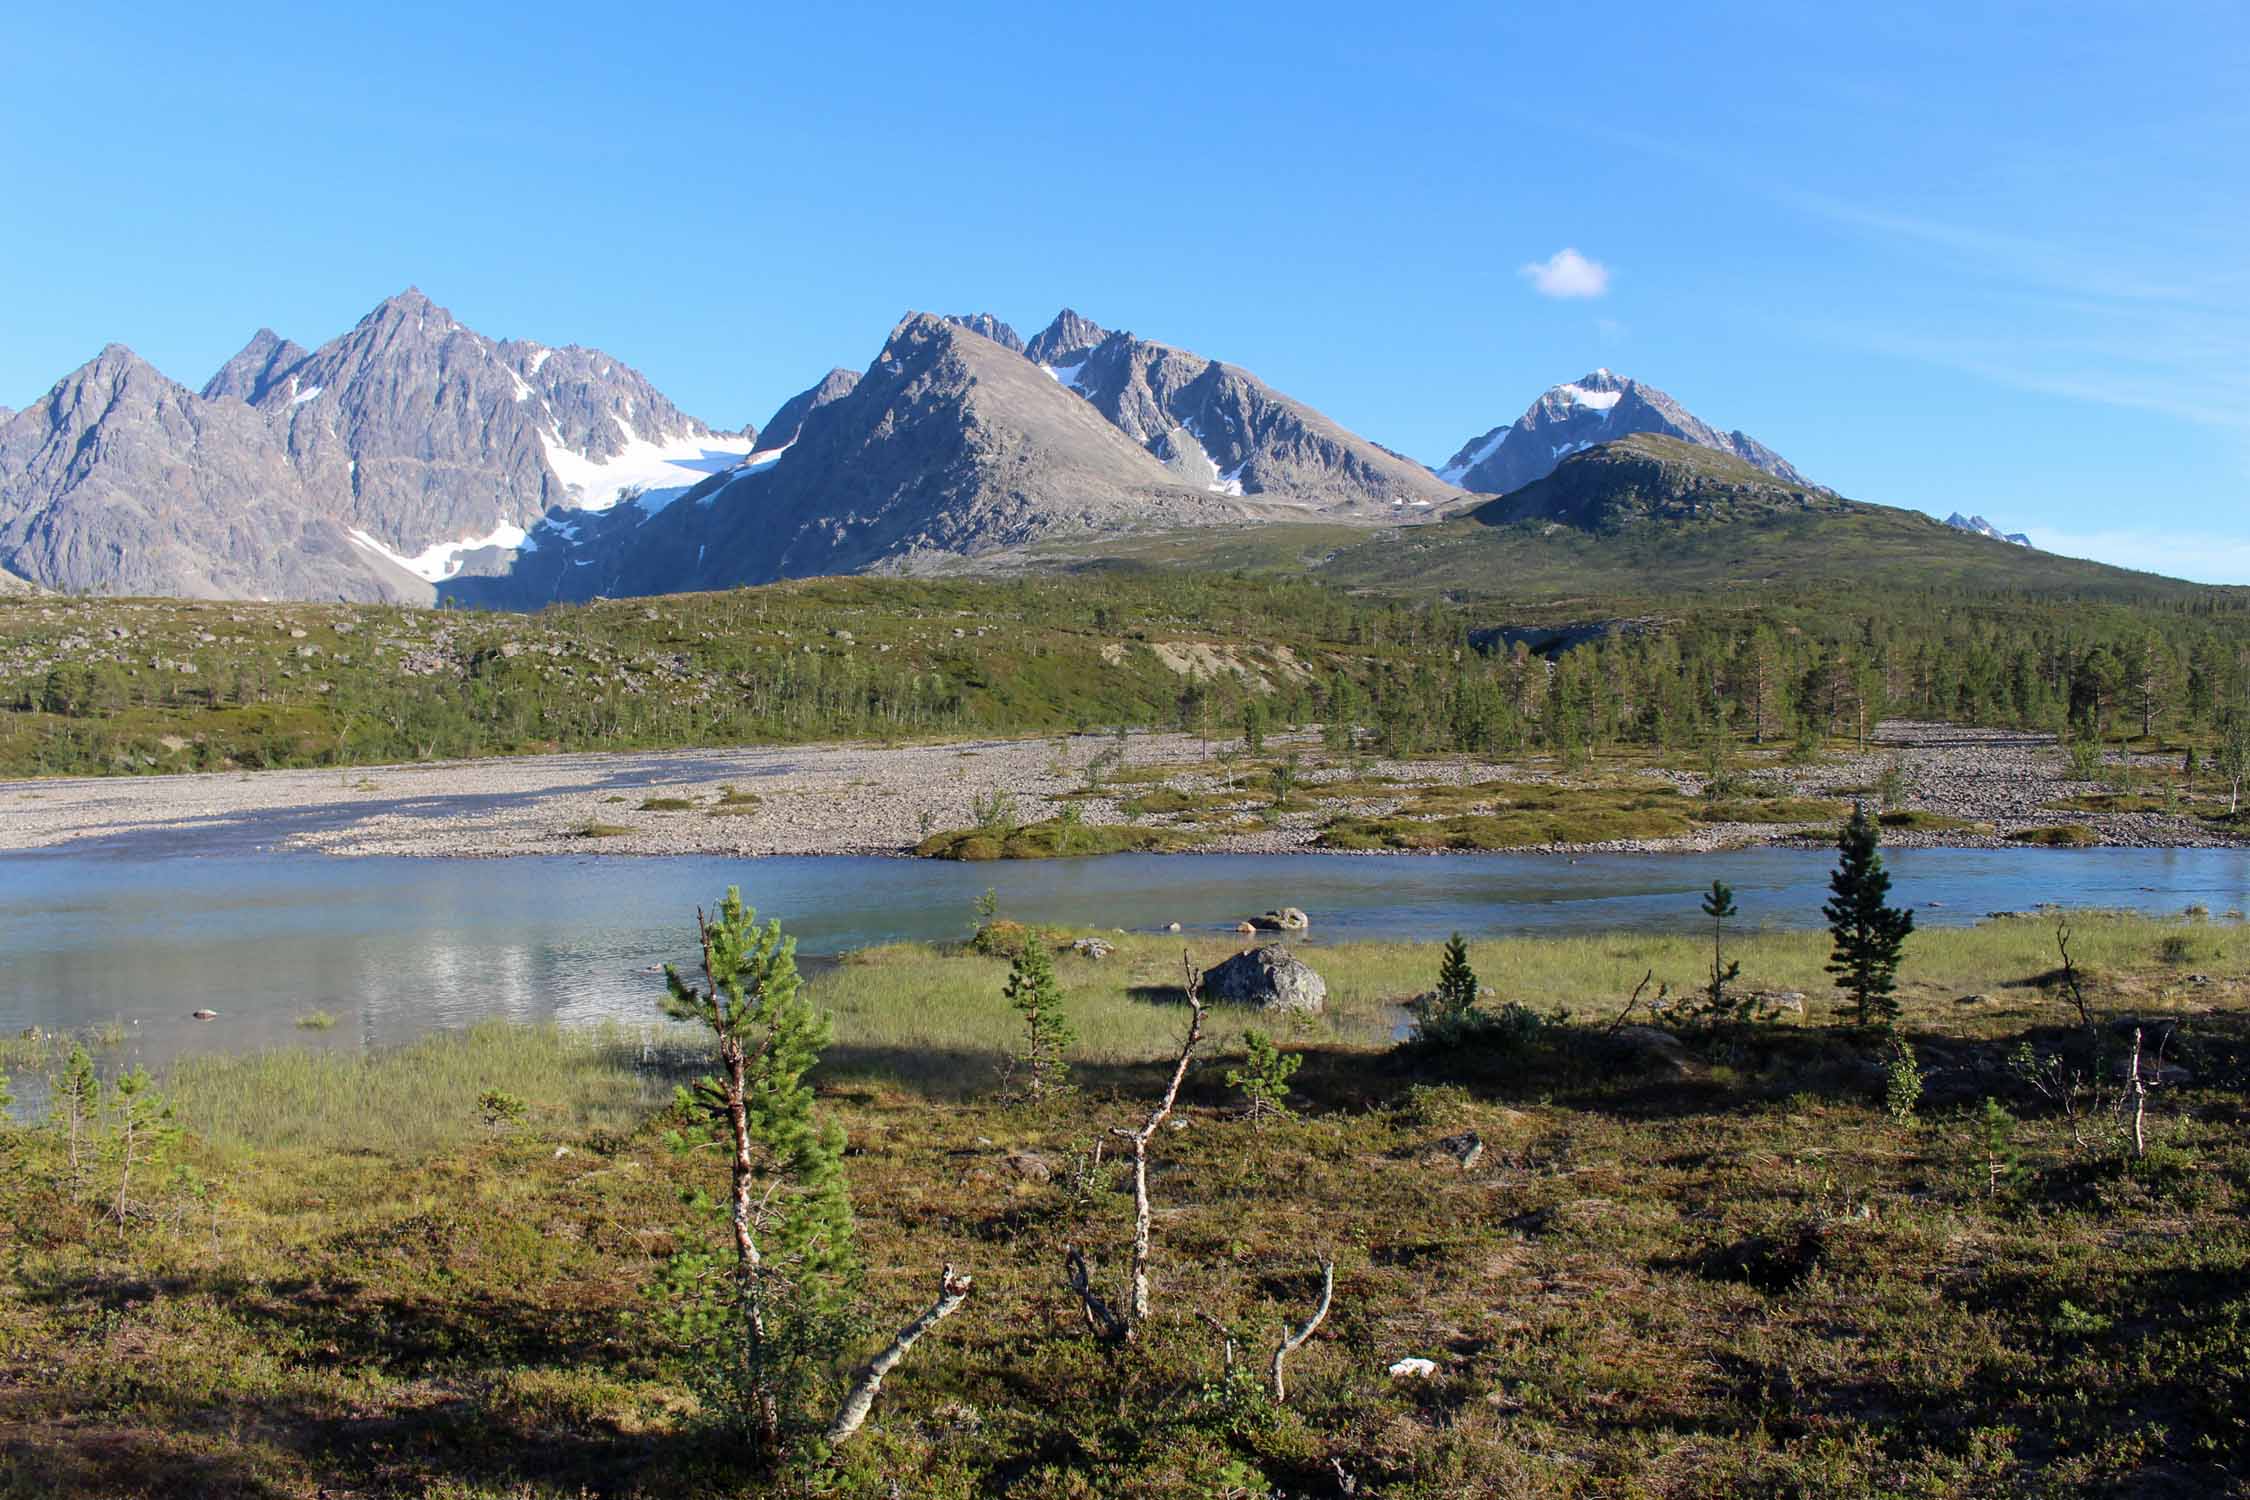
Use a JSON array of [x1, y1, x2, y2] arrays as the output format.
[[0, 722, 2241, 857]]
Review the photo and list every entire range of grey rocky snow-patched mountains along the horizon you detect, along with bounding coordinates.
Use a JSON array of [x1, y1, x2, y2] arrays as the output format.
[[0, 288, 2052, 607]]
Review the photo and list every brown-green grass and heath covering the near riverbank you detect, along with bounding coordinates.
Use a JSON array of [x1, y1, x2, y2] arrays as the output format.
[[0, 913, 2250, 1500]]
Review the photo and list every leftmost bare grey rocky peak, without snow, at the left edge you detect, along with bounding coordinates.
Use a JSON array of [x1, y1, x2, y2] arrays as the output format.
[[0, 344, 430, 603]]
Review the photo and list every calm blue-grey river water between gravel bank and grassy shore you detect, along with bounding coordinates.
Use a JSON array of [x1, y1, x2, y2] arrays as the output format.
[[0, 850, 2250, 1064]]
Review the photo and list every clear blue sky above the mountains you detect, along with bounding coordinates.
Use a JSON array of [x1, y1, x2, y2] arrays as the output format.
[[0, 0, 2250, 582]]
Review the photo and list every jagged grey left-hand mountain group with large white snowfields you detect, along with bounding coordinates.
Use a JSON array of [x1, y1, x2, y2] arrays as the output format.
[[0, 288, 756, 603]]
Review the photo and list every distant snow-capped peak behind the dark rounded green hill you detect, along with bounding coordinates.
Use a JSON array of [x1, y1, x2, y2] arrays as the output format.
[[1438, 369, 1811, 495]]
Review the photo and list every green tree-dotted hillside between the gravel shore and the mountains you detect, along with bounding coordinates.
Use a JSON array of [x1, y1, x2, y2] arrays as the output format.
[[13, 573, 2250, 774]]
